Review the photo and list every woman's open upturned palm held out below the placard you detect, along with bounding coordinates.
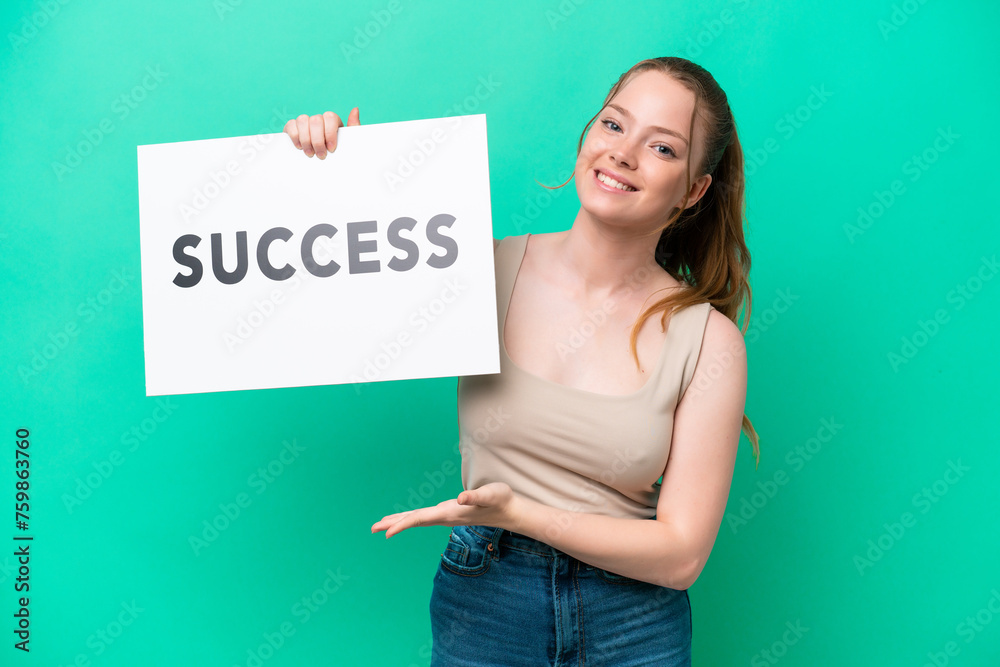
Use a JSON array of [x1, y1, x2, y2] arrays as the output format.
[[372, 482, 520, 539]]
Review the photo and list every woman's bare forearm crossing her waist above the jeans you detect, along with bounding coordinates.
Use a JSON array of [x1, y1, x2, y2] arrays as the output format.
[[502, 496, 700, 589]]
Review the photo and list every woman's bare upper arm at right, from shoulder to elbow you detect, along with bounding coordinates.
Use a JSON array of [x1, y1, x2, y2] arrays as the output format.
[[656, 309, 747, 585]]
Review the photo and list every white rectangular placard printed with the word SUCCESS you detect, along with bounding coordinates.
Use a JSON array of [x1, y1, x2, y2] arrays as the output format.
[[137, 114, 500, 396]]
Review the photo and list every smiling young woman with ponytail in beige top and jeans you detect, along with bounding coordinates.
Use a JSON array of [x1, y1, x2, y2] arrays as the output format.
[[285, 57, 759, 667]]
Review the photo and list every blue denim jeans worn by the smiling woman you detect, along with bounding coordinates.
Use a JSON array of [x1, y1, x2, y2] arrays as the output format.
[[430, 526, 691, 667]]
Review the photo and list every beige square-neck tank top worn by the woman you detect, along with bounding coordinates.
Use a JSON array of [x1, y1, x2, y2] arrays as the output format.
[[458, 234, 712, 519]]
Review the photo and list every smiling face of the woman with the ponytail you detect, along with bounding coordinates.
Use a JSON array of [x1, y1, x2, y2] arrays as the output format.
[[575, 70, 712, 233]]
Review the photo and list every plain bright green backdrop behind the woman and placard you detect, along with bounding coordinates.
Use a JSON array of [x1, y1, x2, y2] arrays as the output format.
[[0, 0, 1000, 667]]
